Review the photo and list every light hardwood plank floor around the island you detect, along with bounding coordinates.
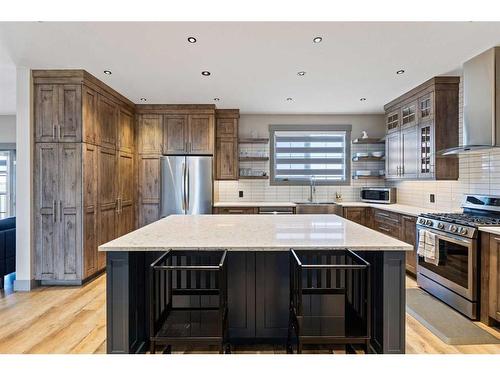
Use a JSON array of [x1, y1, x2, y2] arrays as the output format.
[[0, 275, 500, 354]]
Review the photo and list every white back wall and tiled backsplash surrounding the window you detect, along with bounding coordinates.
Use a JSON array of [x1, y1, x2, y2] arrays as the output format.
[[215, 114, 385, 202]]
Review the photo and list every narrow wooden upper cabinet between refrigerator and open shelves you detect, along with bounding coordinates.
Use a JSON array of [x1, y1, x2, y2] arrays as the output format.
[[215, 109, 240, 180]]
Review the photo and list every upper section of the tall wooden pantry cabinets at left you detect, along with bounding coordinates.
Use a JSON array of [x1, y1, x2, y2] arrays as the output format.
[[33, 70, 134, 152]]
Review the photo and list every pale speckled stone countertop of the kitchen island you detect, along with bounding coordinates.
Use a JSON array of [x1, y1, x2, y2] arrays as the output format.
[[99, 215, 413, 251]]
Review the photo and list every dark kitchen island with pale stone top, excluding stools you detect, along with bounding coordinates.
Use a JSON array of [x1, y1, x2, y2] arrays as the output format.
[[99, 215, 412, 353]]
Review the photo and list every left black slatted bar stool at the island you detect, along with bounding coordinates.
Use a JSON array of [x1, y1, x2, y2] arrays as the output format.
[[150, 250, 230, 354]]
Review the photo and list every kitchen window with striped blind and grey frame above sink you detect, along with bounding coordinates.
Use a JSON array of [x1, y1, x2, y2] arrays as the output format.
[[269, 125, 352, 185]]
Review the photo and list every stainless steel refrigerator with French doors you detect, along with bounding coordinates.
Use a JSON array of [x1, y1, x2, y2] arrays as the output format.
[[160, 155, 213, 217]]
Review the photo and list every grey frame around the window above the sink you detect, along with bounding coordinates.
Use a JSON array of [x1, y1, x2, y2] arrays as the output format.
[[269, 124, 352, 186]]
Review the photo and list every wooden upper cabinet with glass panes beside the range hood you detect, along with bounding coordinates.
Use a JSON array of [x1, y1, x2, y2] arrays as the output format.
[[384, 77, 460, 180]]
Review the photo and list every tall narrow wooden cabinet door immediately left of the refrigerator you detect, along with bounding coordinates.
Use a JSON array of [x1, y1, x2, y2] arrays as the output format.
[[139, 155, 160, 227]]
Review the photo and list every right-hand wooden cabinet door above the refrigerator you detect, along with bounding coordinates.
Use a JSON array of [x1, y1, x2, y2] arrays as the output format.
[[188, 115, 215, 154]]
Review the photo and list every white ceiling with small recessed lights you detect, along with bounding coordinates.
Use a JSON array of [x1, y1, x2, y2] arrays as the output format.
[[0, 22, 500, 113]]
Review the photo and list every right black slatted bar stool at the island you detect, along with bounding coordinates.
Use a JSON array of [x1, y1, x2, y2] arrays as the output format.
[[287, 249, 371, 353]]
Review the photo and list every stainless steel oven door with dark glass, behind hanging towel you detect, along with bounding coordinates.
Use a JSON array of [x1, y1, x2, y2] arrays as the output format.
[[417, 226, 477, 301]]
